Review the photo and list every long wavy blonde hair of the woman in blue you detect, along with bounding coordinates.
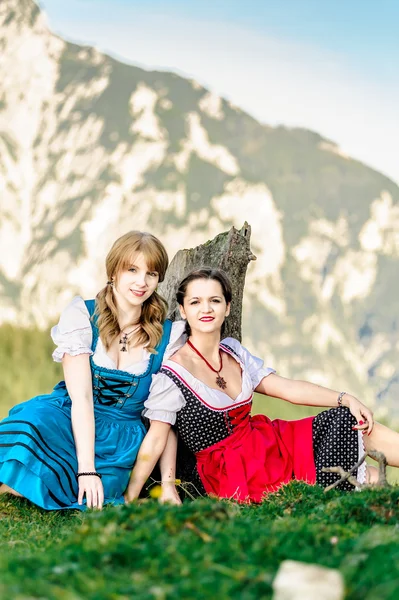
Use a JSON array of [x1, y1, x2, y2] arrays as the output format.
[[95, 231, 169, 353]]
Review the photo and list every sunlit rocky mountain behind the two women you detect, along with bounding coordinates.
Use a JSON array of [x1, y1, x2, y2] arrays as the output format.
[[0, 0, 399, 413]]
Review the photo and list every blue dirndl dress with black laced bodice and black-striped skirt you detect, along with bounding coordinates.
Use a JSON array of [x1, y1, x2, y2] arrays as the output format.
[[0, 300, 172, 510]]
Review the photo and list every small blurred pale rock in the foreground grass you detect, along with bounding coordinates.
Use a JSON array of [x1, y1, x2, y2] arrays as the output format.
[[273, 560, 345, 600]]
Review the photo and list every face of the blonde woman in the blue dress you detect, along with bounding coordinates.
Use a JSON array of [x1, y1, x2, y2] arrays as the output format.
[[114, 252, 159, 310]]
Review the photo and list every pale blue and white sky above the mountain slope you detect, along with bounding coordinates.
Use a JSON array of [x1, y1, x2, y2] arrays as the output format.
[[40, 0, 399, 182]]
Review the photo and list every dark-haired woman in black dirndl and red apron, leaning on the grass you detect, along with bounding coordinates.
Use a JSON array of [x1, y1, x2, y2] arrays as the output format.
[[126, 268, 399, 502]]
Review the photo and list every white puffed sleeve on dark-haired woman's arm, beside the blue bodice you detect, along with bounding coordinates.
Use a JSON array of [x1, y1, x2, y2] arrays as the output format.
[[143, 373, 186, 425]]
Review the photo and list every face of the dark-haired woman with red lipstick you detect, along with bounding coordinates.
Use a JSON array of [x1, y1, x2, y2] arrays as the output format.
[[180, 279, 230, 333]]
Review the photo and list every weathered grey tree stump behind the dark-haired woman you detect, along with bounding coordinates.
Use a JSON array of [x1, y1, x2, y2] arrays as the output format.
[[159, 223, 256, 341]]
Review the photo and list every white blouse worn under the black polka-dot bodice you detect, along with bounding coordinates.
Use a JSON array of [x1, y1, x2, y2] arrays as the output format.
[[143, 338, 275, 425]]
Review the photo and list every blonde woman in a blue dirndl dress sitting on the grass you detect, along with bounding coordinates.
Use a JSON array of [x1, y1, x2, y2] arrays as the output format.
[[0, 231, 185, 510]]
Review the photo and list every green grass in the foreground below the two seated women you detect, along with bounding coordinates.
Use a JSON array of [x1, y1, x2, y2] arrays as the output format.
[[0, 482, 399, 600]]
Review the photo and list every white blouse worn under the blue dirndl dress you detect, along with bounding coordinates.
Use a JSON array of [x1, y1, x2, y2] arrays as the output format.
[[51, 296, 187, 375]]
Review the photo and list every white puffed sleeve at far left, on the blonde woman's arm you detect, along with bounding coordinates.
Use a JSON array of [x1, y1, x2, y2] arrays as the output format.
[[51, 296, 93, 362]]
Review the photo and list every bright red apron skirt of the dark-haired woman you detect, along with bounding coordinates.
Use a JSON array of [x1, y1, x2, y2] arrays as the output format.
[[196, 415, 316, 502]]
